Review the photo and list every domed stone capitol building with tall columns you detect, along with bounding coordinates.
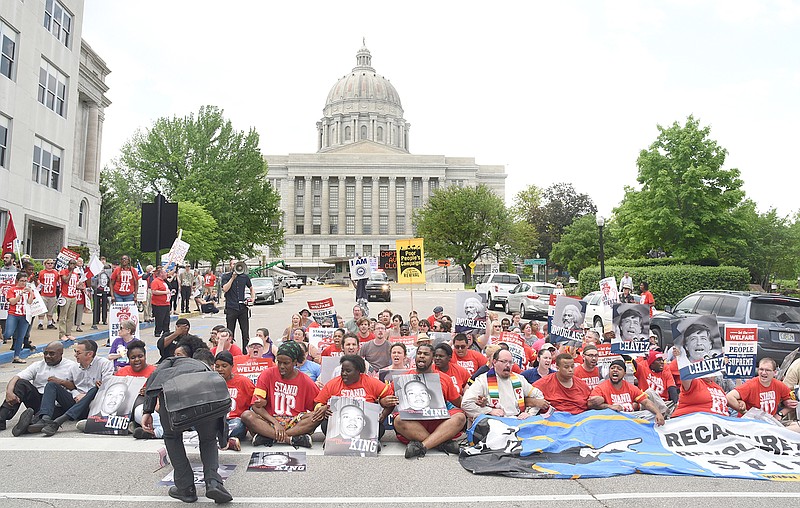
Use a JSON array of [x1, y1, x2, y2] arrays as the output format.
[[265, 46, 506, 276]]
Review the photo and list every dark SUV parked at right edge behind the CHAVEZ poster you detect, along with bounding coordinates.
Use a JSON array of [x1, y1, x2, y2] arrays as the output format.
[[650, 290, 800, 365]]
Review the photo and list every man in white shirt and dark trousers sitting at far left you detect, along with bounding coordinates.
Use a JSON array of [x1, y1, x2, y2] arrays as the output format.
[[0, 341, 77, 436]]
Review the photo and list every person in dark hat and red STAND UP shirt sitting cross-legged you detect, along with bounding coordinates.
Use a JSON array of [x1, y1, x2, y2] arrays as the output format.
[[242, 342, 322, 448]]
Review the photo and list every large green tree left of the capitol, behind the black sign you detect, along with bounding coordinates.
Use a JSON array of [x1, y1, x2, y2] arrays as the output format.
[[104, 102, 284, 262]]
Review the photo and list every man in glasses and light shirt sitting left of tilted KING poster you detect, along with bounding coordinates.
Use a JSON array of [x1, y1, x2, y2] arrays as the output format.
[[24, 339, 114, 437]]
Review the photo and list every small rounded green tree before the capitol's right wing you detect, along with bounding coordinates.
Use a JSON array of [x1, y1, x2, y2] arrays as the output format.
[[413, 185, 512, 284]]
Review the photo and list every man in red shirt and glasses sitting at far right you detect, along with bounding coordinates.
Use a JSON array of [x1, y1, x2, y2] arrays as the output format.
[[727, 357, 797, 420]]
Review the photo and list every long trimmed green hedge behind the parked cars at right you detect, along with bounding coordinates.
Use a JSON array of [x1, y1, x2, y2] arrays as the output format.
[[578, 265, 750, 309]]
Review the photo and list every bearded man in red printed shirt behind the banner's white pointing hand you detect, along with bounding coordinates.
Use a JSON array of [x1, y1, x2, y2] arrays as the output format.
[[589, 359, 664, 425]]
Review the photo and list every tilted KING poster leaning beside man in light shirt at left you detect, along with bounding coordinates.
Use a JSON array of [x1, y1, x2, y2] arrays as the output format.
[[84, 376, 147, 436]]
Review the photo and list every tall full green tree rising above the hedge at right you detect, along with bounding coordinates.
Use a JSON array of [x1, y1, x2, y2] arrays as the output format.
[[615, 116, 744, 264]]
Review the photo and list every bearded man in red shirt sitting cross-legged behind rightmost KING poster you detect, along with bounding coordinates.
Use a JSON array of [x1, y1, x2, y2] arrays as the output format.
[[394, 344, 467, 459]]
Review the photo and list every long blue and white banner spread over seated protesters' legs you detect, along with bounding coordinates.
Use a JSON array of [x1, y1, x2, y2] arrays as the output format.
[[459, 410, 800, 481]]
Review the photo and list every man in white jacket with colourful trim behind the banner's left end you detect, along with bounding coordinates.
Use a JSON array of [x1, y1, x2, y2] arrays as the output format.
[[461, 349, 550, 419]]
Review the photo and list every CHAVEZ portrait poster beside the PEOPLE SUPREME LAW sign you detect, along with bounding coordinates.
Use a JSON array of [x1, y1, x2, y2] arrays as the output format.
[[672, 315, 725, 379]]
